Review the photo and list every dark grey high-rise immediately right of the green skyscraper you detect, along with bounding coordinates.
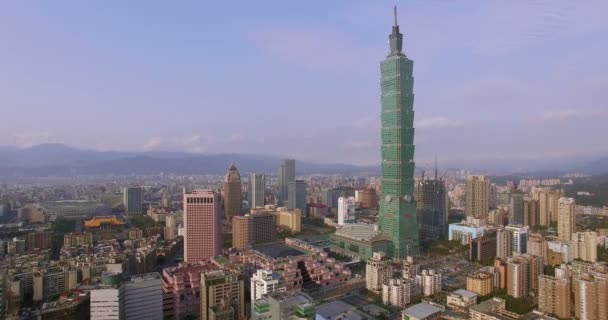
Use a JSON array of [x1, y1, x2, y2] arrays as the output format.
[[416, 178, 448, 242]]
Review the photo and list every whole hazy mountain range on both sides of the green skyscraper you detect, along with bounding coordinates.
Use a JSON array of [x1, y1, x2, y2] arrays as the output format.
[[0, 144, 608, 178]]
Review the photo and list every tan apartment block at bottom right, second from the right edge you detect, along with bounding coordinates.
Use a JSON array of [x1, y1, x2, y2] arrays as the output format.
[[538, 275, 572, 319]]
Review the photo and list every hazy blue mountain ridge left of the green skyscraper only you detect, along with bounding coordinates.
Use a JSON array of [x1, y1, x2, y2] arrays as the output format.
[[0, 144, 379, 177]]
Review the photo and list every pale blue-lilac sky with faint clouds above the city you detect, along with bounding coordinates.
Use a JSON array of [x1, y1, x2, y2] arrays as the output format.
[[0, 0, 608, 165]]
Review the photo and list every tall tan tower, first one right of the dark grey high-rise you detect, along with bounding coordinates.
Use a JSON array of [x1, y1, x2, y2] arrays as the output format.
[[464, 176, 490, 218]]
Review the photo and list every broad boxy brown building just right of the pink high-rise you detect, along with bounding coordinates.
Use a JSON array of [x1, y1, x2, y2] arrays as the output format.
[[232, 212, 277, 249]]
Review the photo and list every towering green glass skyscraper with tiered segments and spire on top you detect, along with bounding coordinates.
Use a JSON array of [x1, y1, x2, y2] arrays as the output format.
[[379, 7, 418, 259]]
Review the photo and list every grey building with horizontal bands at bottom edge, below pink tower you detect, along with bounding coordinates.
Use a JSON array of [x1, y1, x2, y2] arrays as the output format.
[[122, 272, 163, 320]]
